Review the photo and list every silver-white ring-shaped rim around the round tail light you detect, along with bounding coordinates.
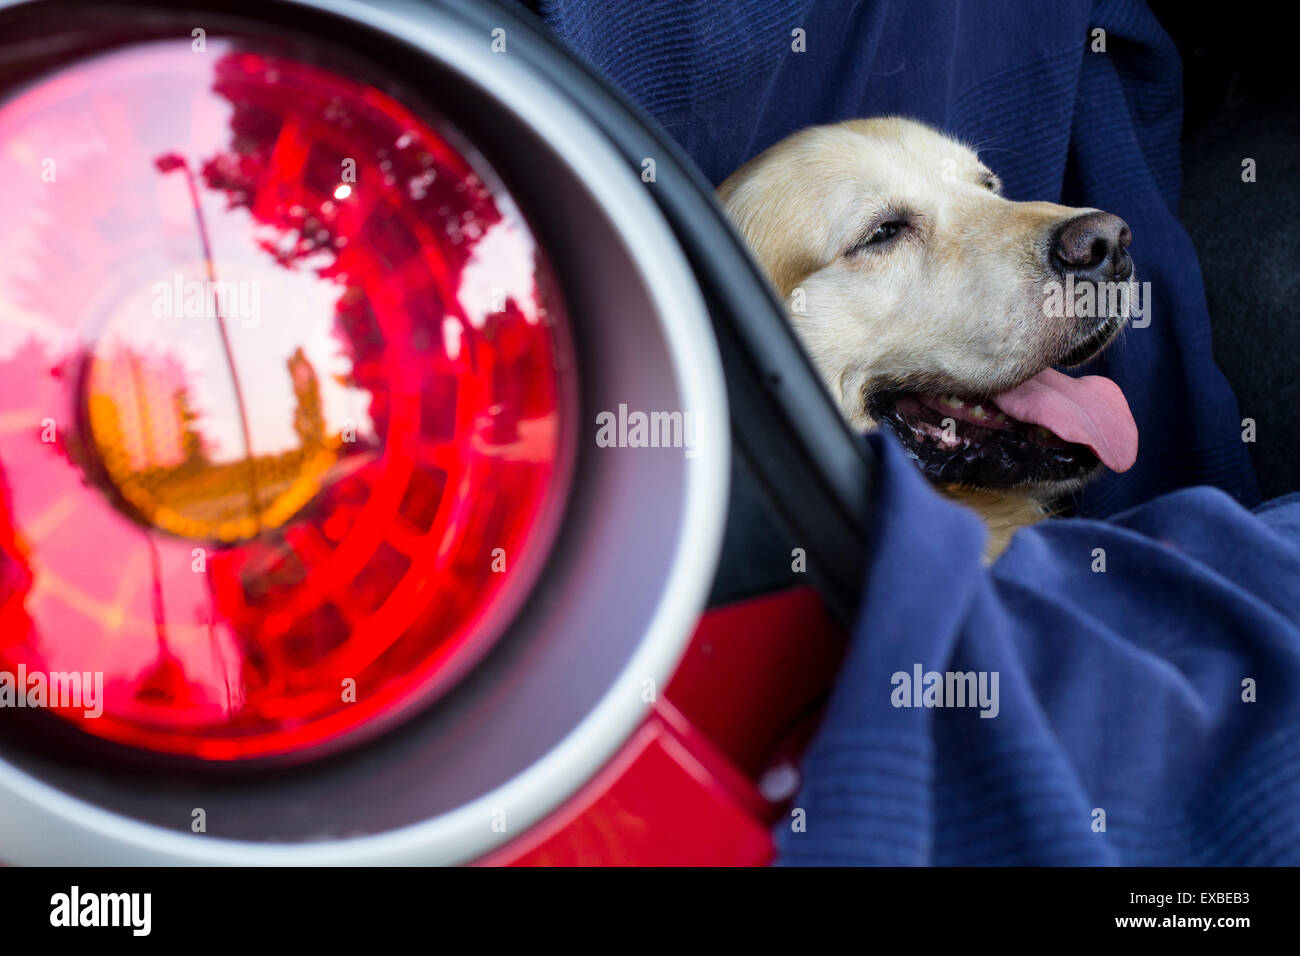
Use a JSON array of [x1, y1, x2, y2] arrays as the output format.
[[0, 0, 731, 866]]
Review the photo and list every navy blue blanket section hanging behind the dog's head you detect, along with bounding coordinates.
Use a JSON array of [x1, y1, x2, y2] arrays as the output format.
[[525, 0, 1258, 515]]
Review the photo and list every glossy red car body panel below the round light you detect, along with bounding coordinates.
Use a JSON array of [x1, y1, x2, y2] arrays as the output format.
[[480, 588, 845, 866]]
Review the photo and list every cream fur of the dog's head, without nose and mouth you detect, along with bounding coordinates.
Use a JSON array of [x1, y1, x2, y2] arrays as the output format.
[[718, 117, 1112, 555]]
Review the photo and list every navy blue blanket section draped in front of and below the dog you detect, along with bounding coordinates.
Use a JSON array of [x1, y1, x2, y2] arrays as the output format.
[[776, 434, 1300, 865]]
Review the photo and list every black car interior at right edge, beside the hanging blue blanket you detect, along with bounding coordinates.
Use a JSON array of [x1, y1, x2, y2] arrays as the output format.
[[1152, 0, 1300, 498]]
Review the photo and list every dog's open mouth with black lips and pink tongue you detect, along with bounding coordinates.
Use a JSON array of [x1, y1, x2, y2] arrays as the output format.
[[868, 327, 1138, 488]]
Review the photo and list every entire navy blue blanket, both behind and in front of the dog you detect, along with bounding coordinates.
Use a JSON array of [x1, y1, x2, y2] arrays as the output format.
[[520, 0, 1300, 864]]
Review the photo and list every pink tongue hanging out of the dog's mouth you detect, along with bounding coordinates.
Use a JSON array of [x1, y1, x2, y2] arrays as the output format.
[[993, 368, 1138, 471]]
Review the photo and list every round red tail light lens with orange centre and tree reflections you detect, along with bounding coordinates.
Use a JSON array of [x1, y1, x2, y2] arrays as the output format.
[[0, 39, 572, 760]]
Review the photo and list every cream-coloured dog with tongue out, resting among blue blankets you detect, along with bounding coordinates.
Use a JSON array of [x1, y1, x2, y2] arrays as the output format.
[[718, 117, 1138, 557]]
